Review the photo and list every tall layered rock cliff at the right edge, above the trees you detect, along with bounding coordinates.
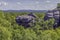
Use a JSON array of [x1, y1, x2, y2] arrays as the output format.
[[44, 10, 60, 28]]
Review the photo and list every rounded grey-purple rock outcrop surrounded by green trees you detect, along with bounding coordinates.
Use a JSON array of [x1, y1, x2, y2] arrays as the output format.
[[16, 13, 36, 27]]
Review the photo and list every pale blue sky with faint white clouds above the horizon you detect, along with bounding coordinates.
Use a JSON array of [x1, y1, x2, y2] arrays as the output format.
[[0, 0, 60, 10]]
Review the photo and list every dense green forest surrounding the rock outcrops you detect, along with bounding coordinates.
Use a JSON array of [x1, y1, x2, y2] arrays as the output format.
[[0, 11, 60, 40]]
